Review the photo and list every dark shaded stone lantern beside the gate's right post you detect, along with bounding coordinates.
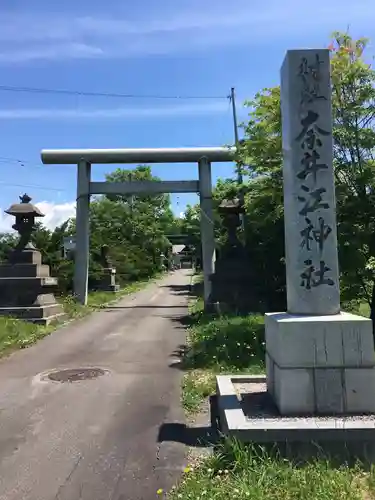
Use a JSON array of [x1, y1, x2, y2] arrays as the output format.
[[210, 198, 251, 312]]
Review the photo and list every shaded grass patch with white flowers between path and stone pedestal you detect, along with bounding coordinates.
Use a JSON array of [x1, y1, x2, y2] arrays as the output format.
[[181, 299, 264, 413]]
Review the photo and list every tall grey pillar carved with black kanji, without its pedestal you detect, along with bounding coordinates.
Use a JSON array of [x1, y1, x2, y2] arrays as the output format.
[[281, 49, 340, 315]]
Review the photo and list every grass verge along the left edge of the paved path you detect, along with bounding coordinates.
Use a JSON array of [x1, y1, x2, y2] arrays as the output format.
[[0, 275, 161, 357]]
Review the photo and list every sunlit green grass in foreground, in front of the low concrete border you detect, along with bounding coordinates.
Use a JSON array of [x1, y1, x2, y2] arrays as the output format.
[[167, 440, 375, 500]]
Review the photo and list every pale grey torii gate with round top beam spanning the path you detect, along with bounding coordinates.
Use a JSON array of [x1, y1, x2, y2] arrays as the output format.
[[41, 147, 235, 305]]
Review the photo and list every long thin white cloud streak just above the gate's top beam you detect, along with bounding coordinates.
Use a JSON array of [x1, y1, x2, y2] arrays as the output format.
[[0, 99, 229, 120]]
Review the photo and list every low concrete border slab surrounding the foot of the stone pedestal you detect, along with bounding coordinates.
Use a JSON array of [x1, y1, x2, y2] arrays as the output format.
[[216, 375, 375, 460]]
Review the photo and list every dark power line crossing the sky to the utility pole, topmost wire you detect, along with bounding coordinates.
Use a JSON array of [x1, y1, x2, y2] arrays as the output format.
[[0, 85, 228, 99]]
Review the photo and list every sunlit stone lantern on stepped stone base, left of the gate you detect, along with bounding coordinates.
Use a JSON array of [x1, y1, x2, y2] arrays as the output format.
[[0, 194, 63, 324]]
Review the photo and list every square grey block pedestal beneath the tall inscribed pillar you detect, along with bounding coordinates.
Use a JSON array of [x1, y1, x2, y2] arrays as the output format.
[[265, 312, 375, 415]]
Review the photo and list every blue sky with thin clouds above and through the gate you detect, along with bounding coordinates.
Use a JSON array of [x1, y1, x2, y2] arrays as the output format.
[[0, 0, 375, 230]]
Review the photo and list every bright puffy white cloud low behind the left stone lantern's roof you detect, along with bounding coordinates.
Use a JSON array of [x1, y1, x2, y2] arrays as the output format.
[[0, 201, 76, 233]]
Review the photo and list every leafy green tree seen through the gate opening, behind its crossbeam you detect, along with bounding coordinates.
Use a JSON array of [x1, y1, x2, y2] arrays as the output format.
[[90, 165, 174, 281]]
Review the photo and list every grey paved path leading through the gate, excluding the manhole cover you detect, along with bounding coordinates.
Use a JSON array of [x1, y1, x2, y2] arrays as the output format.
[[0, 270, 191, 500]]
